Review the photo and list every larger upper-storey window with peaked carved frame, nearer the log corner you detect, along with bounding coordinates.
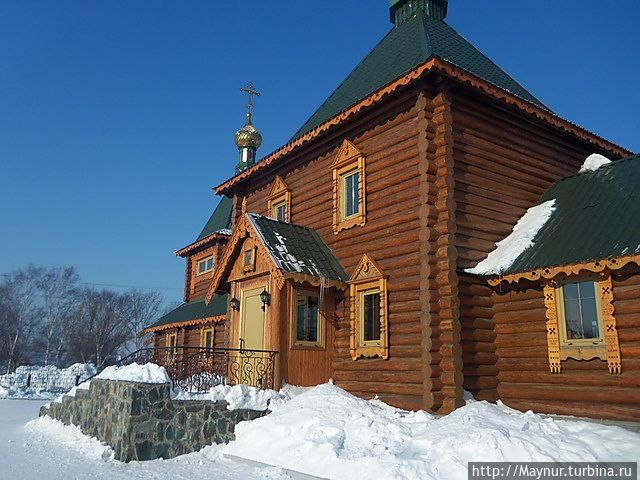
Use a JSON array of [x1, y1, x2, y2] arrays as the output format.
[[332, 140, 366, 234]]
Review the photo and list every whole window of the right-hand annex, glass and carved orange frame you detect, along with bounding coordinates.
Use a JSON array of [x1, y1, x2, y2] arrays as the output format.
[[544, 274, 621, 373]]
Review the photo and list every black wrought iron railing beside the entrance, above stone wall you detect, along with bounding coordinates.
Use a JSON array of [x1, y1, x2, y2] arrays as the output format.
[[92, 347, 278, 392]]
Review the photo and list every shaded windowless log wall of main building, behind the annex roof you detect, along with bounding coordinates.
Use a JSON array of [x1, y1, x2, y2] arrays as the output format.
[[451, 86, 616, 400]]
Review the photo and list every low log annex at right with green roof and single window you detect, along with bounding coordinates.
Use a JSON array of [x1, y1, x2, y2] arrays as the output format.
[[468, 156, 640, 421]]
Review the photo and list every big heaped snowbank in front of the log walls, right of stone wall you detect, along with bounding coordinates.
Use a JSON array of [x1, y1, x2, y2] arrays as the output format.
[[224, 383, 640, 480]]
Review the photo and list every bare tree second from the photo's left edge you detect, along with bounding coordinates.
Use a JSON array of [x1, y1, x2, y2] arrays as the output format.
[[35, 267, 80, 366]]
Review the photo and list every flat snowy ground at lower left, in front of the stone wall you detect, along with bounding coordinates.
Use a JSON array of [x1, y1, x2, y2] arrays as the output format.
[[0, 400, 289, 480]]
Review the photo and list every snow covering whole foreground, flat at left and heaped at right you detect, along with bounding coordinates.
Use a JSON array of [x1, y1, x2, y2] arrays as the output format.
[[0, 383, 640, 480]]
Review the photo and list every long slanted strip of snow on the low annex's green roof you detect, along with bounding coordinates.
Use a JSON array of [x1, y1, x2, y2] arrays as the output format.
[[465, 199, 556, 275]]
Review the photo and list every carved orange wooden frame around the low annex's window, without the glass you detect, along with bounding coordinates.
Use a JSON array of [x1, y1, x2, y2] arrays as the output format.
[[544, 275, 622, 374]]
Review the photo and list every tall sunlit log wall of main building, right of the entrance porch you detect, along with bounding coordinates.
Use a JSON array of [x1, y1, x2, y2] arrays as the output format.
[[242, 88, 425, 409]]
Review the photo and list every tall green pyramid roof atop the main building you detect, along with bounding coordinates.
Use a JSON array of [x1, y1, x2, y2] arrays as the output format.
[[293, 10, 549, 138]]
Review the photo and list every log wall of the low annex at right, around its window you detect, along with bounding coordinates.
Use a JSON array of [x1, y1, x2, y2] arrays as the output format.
[[494, 275, 640, 421]]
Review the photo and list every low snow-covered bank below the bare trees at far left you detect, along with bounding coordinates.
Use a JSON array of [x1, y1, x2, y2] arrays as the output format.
[[0, 363, 96, 400]]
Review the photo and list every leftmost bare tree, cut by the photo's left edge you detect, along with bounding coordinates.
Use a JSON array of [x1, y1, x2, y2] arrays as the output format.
[[2, 265, 42, 373]]
